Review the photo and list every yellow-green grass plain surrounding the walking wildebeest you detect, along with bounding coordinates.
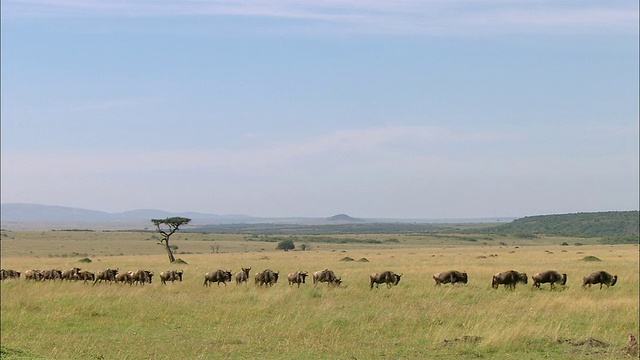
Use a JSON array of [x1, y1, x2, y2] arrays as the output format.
[[1, 231, 639, 359]]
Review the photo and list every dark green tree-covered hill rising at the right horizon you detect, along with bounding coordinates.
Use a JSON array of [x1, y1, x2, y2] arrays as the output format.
[[489, 211, 640, 242]]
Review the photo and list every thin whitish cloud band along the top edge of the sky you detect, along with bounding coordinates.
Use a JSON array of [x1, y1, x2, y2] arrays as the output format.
[[3, 0, 638, 35]]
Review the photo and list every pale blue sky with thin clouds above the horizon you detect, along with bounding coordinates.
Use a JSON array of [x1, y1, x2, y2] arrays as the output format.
[[1, 0, 639, 219]]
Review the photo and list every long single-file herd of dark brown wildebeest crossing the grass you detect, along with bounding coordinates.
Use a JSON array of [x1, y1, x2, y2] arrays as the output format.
[[0, 267, 618, 290]]
